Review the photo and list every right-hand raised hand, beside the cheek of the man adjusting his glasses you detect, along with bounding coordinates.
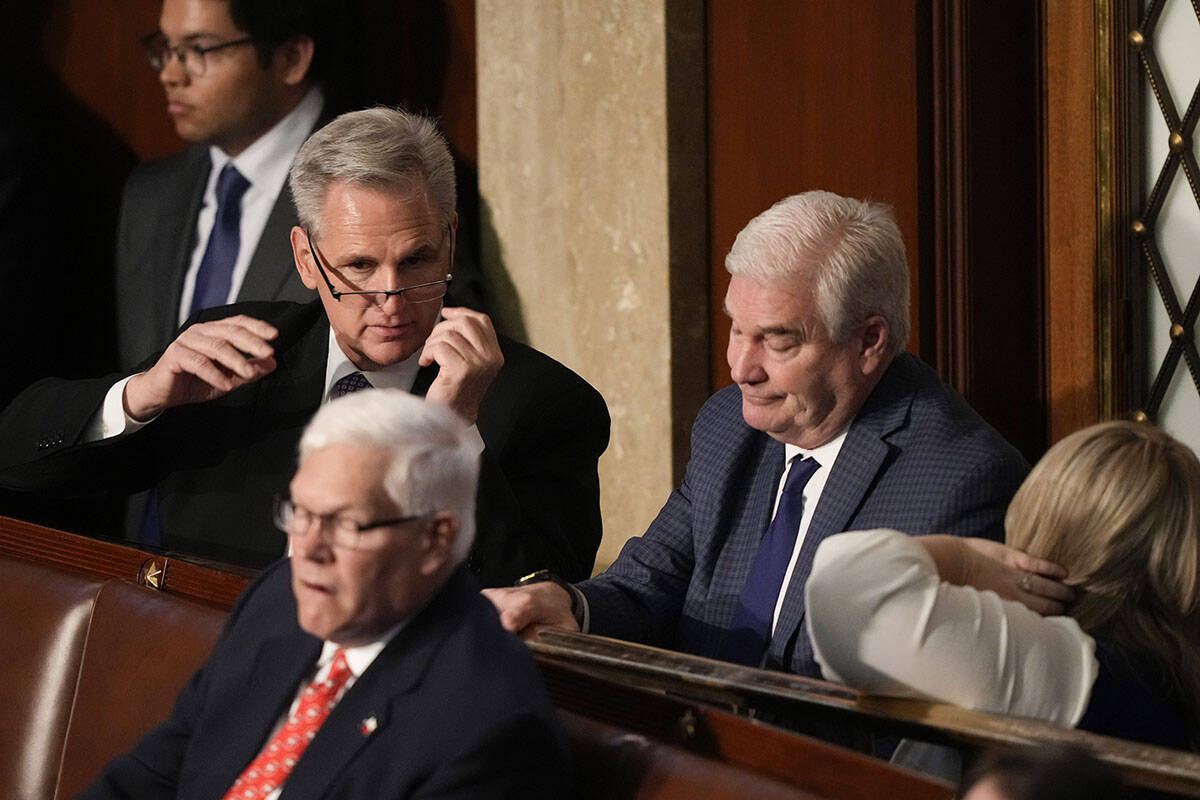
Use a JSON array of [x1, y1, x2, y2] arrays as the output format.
[[421, 308, 504, 423]]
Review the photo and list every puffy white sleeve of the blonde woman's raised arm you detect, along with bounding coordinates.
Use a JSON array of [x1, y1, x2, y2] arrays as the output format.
[[805, 530, 1098, 726]]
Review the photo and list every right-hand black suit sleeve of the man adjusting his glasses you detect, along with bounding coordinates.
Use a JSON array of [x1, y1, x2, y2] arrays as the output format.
[[468, 354, 608, 587]]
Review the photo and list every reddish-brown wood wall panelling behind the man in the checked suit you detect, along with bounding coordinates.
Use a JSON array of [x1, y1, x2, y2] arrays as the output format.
[[708, 0, 1046, 459]]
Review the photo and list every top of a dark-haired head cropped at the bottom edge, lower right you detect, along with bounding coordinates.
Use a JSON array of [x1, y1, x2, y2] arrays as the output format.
[[962, 745, 1140, 800]]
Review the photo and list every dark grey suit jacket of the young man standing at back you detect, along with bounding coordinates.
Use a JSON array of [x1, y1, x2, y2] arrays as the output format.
[[116, 145, 313, 369]]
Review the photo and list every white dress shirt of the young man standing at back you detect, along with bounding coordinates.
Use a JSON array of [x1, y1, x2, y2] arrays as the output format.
[[179, 86, 325, 324]]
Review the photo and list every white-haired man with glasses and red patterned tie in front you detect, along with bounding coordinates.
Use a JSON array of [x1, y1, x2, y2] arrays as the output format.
[[82, 390, 566, 800]]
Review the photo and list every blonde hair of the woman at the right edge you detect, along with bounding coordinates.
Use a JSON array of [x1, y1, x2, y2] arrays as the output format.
[[1004, 422, 1200, 732]]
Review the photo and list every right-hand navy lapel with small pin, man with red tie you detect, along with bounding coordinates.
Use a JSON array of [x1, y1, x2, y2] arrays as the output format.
[[281, 569, 478, 800]]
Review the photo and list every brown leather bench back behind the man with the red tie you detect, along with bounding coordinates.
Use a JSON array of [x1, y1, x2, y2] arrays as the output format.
[[0, 555, 926, 800]]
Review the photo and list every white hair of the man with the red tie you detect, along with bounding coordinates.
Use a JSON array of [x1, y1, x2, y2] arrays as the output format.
[[300, 389, 479, 564]]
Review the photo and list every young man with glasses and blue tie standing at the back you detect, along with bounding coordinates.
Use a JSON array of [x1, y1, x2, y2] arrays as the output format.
[[116, 0, 332, 368]]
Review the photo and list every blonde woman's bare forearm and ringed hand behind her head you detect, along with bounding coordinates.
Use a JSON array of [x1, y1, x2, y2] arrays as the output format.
[[917, 536, 1075, 616]]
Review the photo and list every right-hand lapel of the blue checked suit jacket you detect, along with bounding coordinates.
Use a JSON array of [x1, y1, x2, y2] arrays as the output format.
[[770, 355, 912, 664]]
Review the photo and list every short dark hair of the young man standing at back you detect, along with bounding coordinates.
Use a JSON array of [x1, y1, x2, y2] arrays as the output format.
[[229, 0, 340, 82]]
